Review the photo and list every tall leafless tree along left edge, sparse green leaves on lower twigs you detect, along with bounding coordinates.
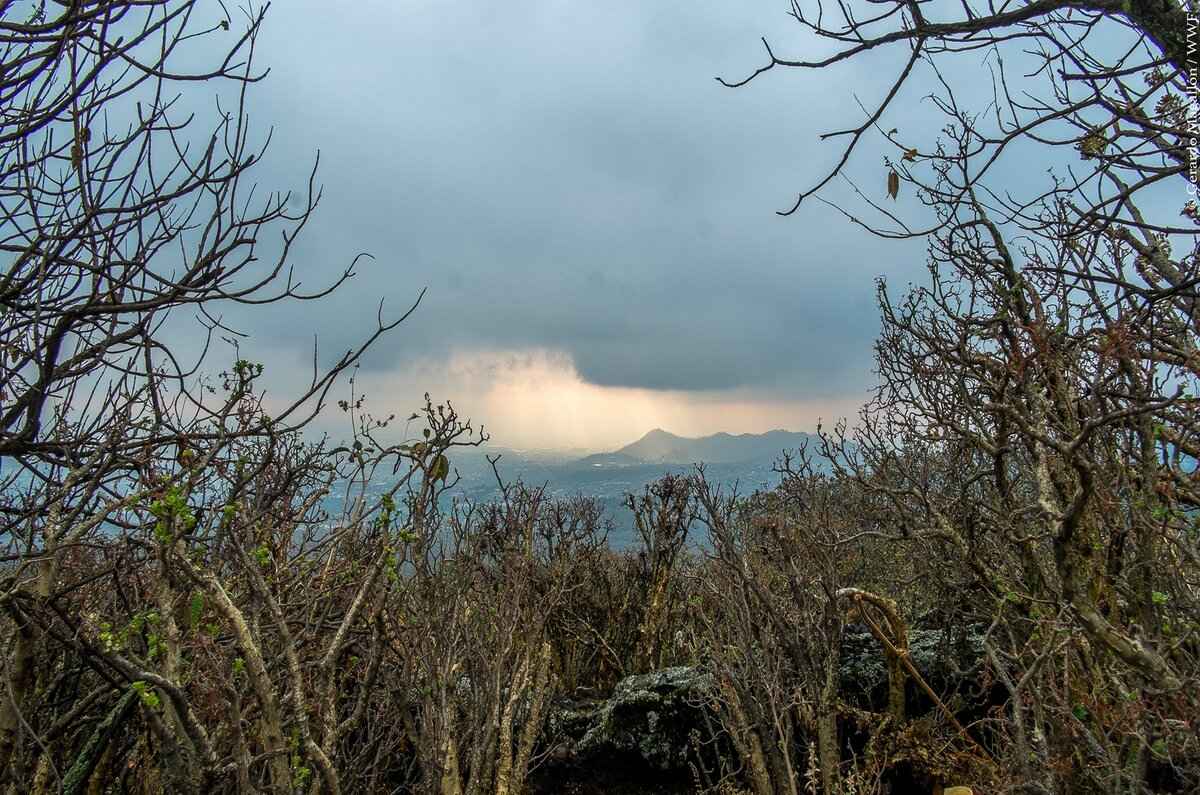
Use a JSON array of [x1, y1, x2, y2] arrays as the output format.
[[0, 0, 432, 791]]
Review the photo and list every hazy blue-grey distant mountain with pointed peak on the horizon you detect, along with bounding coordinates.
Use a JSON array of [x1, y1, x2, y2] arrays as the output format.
[[580, 428, 815, 466]]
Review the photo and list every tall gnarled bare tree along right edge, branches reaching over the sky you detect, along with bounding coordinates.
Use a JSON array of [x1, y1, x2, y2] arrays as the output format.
[[731, 0, 1200, 791]]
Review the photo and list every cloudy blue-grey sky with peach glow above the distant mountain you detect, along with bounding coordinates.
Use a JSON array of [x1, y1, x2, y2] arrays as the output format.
[[192, 0, 938, 450]]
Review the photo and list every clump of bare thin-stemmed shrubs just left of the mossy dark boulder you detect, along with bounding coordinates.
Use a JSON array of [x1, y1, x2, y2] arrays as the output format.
[[391, 475, 614, 795]]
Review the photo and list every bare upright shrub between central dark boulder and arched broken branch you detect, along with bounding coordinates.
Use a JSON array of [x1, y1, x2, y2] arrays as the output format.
[[697, 450, 868, 795]]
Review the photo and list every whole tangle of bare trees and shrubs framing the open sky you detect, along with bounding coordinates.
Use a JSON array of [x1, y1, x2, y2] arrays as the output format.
[[0, 0, 1200, 795]]
